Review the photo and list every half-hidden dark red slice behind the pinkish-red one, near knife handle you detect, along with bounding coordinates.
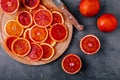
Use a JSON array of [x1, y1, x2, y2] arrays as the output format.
[[52, 11, 64, 24]]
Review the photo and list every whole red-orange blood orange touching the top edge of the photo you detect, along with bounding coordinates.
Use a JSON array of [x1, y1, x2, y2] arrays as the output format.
[[79, 0, 100, 17]]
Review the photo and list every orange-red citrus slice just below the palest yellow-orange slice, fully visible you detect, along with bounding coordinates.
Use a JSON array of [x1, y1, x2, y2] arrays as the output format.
[[11, 38, 31, 57]]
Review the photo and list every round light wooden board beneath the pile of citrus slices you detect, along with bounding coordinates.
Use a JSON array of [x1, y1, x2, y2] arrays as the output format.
[[0, 0, 73, 65]]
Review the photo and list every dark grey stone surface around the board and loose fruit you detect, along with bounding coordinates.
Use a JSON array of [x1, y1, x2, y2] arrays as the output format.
[[0, 0, 120, 80]]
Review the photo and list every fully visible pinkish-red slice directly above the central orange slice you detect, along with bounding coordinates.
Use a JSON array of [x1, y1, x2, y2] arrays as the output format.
[[33, 9, 53, 28]]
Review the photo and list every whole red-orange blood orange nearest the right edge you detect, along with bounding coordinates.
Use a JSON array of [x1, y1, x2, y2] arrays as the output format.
[[97, 14, 118, 32]]
